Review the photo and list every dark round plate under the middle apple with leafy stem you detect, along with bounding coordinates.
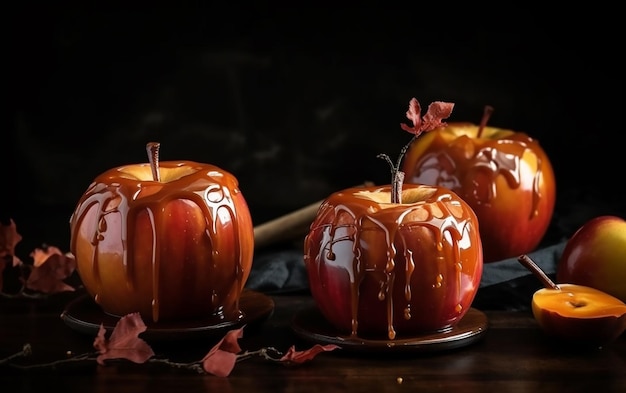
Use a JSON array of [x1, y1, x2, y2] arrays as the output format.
[[292, 307, 488, 352]]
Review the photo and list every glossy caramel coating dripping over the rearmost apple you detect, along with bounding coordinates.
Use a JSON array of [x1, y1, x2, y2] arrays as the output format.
[[412, 137, 542, 219]]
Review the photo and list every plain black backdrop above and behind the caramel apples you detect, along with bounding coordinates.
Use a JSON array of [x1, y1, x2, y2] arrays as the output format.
[[0, 2, 626, 254]]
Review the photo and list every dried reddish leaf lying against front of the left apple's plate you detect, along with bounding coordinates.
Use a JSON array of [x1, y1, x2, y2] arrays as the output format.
[[93, 313, 154, 365]]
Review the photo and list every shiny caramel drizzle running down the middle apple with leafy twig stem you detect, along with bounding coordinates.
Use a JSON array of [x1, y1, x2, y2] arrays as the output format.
[[316, 194, 468, 340]]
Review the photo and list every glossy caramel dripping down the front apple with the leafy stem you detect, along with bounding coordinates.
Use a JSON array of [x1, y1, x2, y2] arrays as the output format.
[[316, 193, 468, 340]]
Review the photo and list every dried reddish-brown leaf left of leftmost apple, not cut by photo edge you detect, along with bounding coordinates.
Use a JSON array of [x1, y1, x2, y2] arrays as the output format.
[[26, 246, 76, 294]]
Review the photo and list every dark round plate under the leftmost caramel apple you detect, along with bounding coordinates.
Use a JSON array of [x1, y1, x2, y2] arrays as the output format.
[[61, 290, 274, 340]]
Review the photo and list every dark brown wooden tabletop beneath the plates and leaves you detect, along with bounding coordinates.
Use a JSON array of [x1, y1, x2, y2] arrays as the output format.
[[0, 293, 626, 393]]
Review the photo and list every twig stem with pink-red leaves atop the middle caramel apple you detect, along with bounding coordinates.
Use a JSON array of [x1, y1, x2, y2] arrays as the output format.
[[376, 98, 454, 203]]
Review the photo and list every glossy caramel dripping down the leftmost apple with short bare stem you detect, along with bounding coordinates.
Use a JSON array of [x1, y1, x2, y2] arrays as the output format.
[[70, 163, 244, 322]]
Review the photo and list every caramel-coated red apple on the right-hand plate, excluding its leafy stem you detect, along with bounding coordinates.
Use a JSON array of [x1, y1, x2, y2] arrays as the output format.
[[304, 184, 483, 339]]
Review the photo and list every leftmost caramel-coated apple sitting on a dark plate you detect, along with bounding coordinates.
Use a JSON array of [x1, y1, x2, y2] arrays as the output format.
[[70, 161, 254, 323]]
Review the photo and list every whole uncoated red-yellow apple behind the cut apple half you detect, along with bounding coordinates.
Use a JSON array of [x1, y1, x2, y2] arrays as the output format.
[[556, 215, 626, 302]]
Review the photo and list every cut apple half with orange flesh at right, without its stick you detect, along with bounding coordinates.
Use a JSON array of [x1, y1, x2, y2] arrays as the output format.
[[532, 284, 626, 345]]
